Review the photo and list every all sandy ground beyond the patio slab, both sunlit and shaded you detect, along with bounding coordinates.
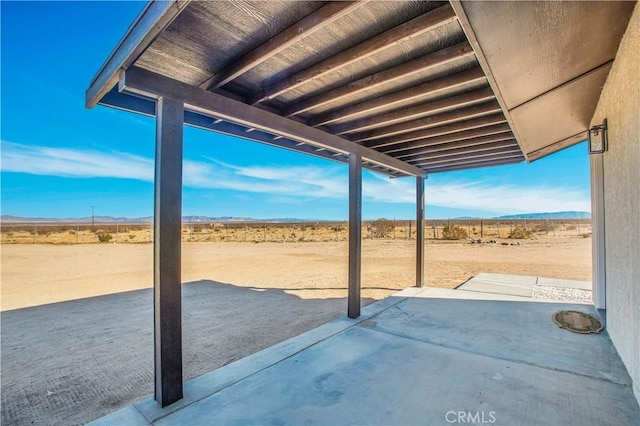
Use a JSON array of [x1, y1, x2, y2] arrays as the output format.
[[1, 236, 591, 424]]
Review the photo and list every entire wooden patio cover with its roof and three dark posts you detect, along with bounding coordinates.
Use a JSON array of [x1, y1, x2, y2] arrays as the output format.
[[86, 1, 634, 405]]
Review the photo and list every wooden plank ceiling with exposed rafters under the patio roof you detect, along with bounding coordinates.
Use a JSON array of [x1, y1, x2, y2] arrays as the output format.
[[88, 1, 636, 176]]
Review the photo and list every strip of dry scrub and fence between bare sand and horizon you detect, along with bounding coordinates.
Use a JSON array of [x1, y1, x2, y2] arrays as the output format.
[[0, 218, 590, 244]]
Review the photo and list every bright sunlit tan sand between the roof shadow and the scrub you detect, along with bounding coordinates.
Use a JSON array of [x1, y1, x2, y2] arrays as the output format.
[[0, 236, 591, 311]]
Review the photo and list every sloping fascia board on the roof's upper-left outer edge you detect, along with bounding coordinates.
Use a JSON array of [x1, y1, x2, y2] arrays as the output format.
[[85, 0, 191, 108]]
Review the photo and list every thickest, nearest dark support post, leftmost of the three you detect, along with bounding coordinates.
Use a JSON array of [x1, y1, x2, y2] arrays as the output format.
[[153, 98, 184, 407]]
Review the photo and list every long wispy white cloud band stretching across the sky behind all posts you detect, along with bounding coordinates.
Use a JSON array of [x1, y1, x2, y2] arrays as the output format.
[[2, 141, 590, 213]]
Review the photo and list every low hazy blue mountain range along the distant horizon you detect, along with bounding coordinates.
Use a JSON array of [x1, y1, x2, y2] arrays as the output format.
[[0, 211, 591, 223]]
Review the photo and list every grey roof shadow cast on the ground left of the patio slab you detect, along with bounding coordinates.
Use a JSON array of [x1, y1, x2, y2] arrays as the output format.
[[0, 280, 373, 424]]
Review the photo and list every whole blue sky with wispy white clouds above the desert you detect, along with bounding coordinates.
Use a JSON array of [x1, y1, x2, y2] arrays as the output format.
[[0, 1, 590, 220]]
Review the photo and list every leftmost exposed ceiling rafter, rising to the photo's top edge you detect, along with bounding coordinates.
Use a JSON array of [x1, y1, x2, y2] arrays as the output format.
[[199, 1, 366, 90]]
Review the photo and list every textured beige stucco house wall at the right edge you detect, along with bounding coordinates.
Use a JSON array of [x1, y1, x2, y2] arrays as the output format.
[[591, 4, 640, 401]]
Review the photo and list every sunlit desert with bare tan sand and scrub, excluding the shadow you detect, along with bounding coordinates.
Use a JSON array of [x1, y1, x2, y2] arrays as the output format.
[[0, 220, 591, 311]]
